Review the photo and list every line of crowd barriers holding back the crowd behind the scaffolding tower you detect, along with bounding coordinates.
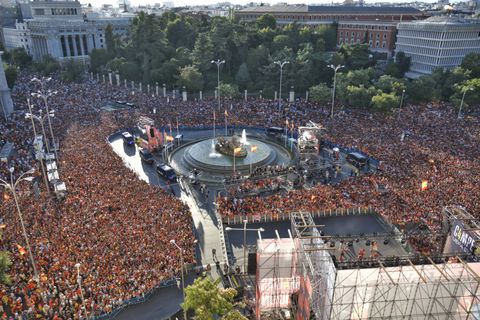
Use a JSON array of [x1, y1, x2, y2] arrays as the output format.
[[222, 207, 376, 225]]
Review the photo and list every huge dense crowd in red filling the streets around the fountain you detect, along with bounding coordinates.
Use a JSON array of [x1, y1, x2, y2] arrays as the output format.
[[0, 72, 480, 319]]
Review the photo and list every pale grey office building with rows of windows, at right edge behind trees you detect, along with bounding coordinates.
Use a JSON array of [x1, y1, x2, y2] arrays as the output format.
[[396, 16, 480, 78]]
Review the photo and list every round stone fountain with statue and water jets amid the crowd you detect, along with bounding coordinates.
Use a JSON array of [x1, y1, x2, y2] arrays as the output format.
[[169, 129, 293, 183]]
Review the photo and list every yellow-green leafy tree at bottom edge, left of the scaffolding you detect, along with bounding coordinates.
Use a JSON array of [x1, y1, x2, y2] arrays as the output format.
[[182, 277, 237, 320]]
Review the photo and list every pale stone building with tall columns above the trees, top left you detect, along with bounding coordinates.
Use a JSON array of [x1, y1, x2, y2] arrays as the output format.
[[4, 0, 131, 60]]
